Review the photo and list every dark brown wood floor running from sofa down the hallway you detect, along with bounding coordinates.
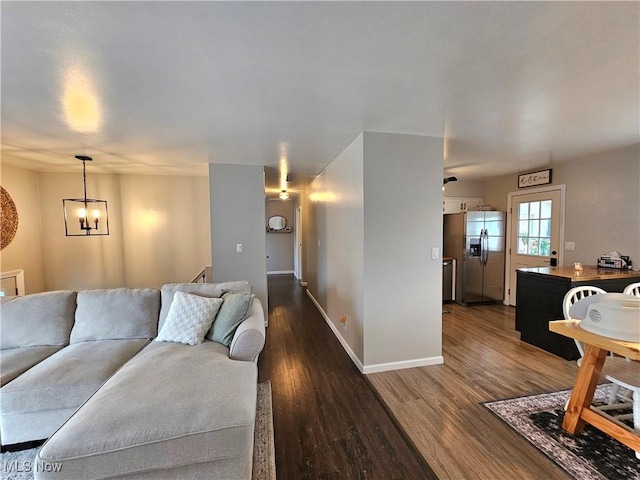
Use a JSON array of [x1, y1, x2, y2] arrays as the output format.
[[258, 275, 436, 480]]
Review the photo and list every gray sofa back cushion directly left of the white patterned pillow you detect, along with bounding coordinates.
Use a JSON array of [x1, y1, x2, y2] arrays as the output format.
[[71, 288, 160, 343]]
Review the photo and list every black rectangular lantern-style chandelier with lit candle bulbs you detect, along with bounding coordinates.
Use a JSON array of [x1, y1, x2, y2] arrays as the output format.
[[62, 155, 109, 237]]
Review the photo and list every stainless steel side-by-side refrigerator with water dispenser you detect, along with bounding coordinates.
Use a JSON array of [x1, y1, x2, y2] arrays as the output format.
[[444, 211, 506, 305]]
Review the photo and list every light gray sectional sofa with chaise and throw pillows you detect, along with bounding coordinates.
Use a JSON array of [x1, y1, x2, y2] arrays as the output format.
[[0, 282, 265, 480]]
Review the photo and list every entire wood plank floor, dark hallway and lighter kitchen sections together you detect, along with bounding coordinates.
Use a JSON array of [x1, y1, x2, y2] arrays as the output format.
[[259, 275, 577, 480]]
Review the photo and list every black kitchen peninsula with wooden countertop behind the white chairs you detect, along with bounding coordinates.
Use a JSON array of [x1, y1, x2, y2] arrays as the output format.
[[516, 265, 640, 360]]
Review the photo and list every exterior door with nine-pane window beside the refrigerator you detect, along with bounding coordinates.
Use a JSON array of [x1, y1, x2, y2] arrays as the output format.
[[508, 189, 564, 305]]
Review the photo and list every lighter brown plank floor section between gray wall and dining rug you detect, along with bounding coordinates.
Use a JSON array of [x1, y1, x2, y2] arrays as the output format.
[[368, 304, 577, 479]]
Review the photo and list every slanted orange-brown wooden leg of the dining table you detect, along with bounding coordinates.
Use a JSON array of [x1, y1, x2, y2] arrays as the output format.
[[562, 345, 608, 434]]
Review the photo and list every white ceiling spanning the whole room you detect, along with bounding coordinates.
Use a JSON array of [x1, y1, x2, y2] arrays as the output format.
[[1, 1, 640, 193]]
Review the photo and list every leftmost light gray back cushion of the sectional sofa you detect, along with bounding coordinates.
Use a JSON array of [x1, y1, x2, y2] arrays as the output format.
[[0, 290, 76, 350]]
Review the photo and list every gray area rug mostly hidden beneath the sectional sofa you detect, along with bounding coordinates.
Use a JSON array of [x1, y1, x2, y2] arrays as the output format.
[[0, 381, 276, 480]]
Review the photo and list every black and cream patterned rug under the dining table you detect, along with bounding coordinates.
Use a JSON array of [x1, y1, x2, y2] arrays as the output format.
[[483, 385, 640, 480]]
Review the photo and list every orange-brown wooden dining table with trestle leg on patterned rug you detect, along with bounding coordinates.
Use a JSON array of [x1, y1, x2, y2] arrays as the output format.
[[549, 320, 640, 452]]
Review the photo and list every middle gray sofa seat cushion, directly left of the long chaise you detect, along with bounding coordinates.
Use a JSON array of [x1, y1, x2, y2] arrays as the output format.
[[0, 339, 149, 414]]
